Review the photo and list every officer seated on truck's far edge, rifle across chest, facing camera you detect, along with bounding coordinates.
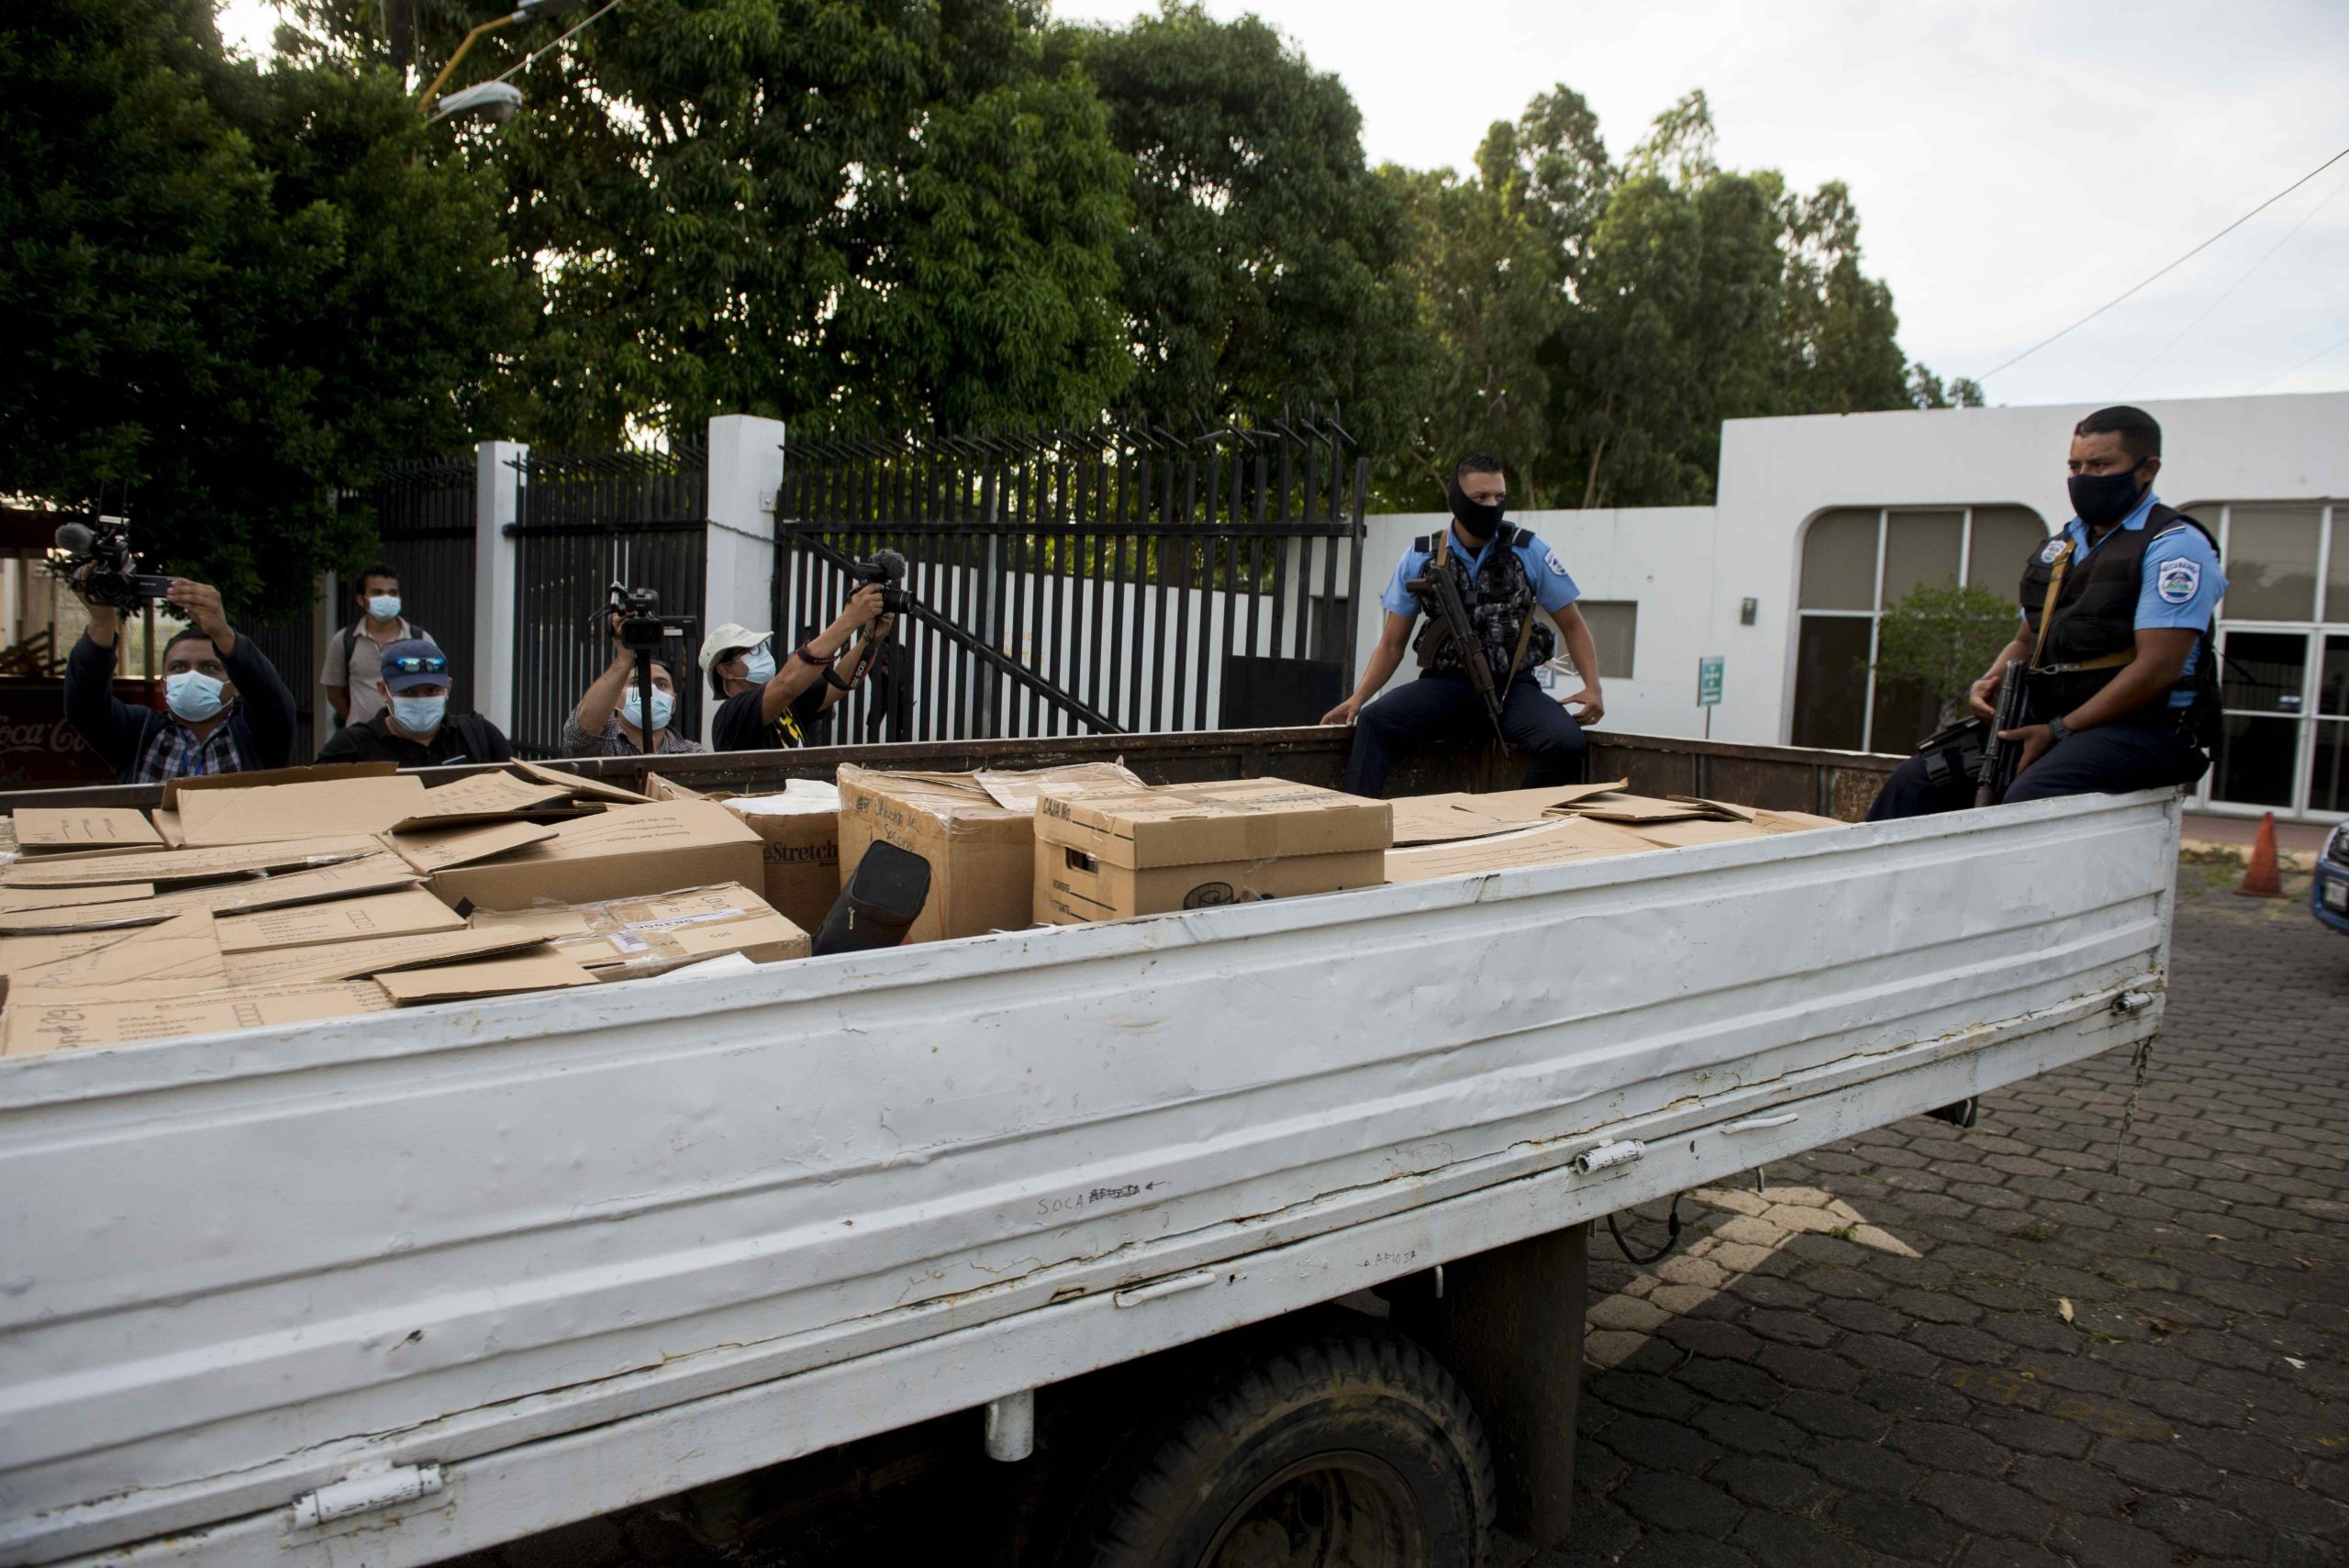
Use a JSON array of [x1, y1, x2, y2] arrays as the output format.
[[1322, 453, 1607, 795]]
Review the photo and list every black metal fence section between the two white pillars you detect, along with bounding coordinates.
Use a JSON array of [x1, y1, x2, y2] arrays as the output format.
[[507, 444, 709, 756]]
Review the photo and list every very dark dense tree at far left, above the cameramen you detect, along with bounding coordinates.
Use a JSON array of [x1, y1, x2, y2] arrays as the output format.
[[0, 0, 526, 613]]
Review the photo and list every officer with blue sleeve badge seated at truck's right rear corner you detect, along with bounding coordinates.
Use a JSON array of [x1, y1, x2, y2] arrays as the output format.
[[1867, 406, 2227, 821]]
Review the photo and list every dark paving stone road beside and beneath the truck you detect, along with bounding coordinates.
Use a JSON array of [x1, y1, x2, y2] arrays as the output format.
[[470, 866, 2349, 1568]]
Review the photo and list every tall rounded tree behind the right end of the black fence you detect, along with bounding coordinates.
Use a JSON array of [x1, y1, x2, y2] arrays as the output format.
[[1057, 0, 1423, 449]]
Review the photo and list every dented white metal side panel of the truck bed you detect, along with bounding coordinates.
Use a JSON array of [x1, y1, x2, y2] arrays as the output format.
[[0, 791, 2177, 1565]]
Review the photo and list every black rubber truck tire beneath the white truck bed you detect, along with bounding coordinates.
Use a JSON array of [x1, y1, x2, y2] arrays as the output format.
[[1069, 1329, 1494, 1568]]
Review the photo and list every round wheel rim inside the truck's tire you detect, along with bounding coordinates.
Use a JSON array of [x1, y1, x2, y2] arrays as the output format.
[[1198, 1451, 1431, 1568]]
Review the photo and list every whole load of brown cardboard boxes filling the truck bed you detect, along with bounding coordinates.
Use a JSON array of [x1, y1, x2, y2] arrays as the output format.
[[0, 762, 1839, 1056]]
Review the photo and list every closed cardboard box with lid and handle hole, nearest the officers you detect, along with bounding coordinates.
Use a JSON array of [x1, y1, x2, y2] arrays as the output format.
[[1033, 779, 1393, 925]]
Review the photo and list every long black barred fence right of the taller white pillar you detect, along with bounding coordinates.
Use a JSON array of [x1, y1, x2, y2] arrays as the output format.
[[775, 413, 1367, 744]]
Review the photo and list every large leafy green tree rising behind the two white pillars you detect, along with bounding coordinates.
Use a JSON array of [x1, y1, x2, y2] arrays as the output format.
[[324, 0, 1132, 441]]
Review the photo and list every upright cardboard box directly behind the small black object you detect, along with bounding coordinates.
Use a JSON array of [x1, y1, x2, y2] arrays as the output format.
[[818, 765, 1036, 943]]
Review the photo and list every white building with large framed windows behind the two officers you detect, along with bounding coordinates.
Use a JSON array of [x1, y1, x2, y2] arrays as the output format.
[[1358, 392, 2349, 821]]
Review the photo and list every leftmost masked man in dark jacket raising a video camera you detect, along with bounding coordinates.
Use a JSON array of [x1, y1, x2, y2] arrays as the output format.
[[56, 518, 294, 784]]
